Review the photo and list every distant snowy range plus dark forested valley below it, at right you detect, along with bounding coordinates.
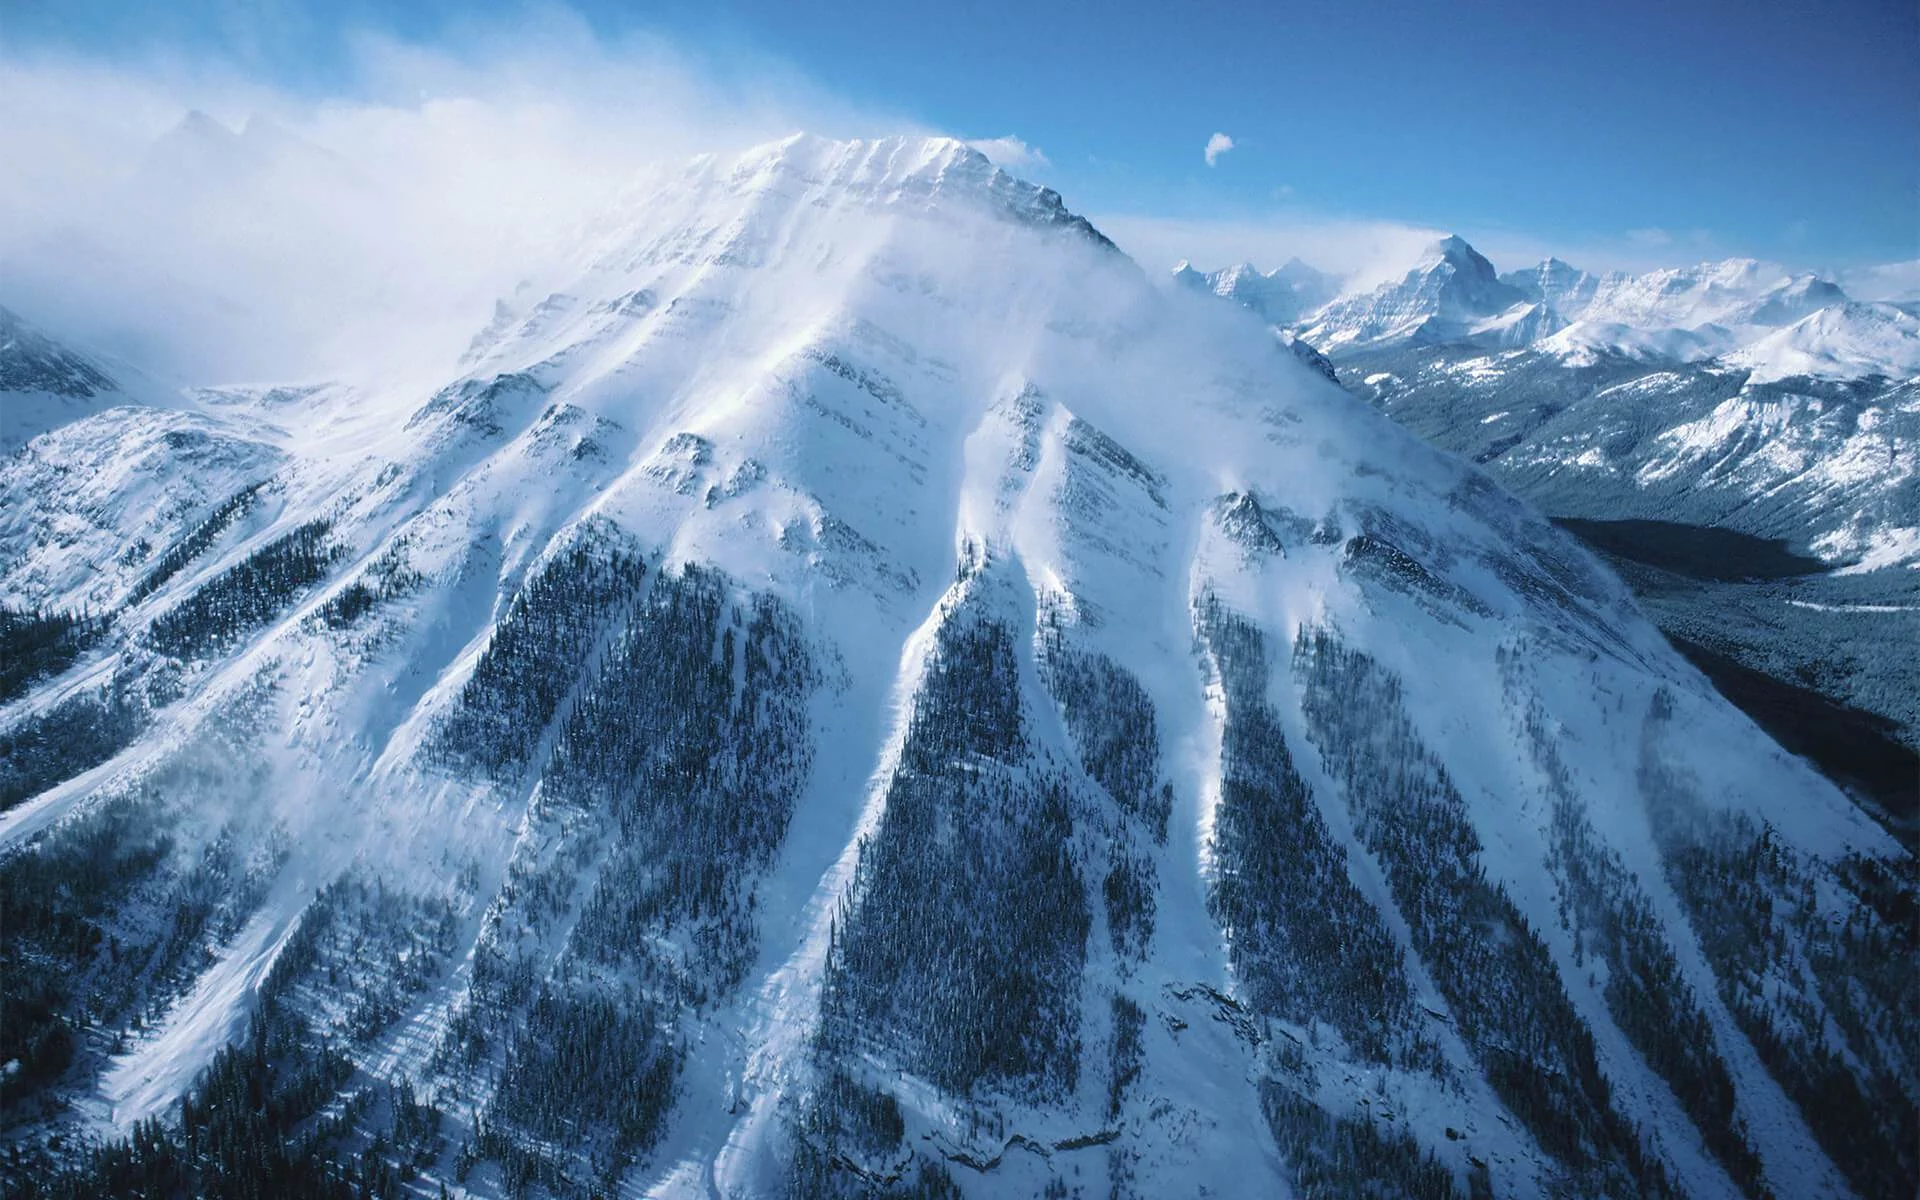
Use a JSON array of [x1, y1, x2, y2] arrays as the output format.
[[1175, 238, 1920, 843]]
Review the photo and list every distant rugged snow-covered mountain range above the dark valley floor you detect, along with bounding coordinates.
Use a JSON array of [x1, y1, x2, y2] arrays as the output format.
[[1188, 238, 1920, 568]]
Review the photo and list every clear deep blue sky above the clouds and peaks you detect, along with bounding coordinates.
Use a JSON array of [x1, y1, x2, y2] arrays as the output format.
[[0, 0, 1920, 267]]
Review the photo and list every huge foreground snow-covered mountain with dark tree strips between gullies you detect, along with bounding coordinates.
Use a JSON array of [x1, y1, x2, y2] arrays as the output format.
[[0, 136, 1920, 1198]]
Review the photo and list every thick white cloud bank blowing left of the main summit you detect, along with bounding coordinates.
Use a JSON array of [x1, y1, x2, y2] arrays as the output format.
[[0, 10, 914, 382]]
